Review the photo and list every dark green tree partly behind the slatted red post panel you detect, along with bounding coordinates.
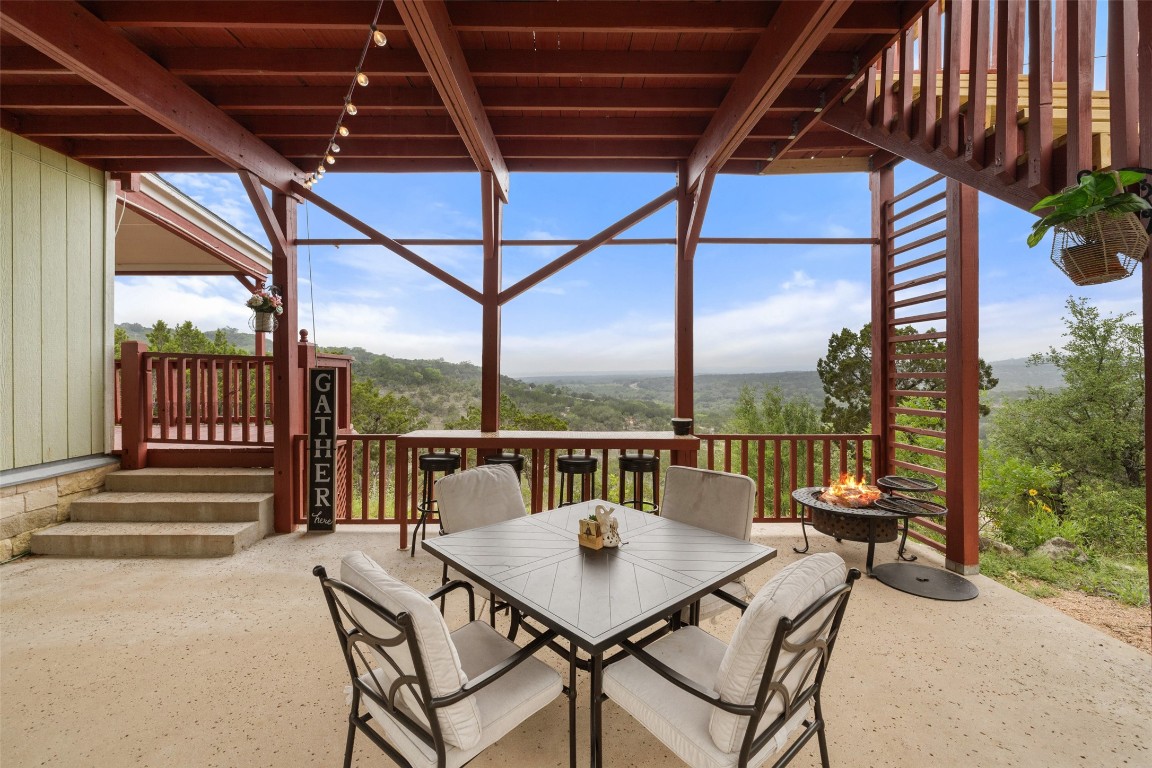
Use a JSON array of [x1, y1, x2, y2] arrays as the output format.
[[816, 324, 999, 433]]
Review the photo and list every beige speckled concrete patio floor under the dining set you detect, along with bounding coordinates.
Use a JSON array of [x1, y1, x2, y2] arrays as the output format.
[[0, 525, 1152, 768]]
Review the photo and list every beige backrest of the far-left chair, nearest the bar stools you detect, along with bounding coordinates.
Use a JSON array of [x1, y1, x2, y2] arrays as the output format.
[[435, 464, 526, 533]]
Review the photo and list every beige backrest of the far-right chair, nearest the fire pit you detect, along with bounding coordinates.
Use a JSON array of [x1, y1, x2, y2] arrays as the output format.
[[660, 466, 756, 541]]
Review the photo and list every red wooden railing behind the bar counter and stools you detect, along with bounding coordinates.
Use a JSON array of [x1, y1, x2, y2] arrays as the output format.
[[293, 434, 877, 524]]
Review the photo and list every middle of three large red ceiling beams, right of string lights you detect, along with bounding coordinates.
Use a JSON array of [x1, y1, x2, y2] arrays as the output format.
[[396, 0, 508, 203]]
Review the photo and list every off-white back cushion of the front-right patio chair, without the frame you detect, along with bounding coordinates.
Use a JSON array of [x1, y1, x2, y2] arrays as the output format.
[[708, 553, 848, 752]]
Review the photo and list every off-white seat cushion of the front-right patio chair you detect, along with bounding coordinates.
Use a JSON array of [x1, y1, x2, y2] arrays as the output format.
[[604, 626, 808, 768]]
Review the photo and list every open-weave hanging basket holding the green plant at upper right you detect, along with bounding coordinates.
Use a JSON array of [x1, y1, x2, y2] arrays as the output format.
[[1052, 213, 1149, 286]]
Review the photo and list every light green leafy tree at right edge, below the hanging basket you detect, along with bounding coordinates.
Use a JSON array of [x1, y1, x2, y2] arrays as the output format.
[[990, 298, 1145, 491]]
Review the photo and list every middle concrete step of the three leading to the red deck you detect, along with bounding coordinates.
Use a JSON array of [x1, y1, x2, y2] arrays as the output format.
[[69, 491, 273, 523]]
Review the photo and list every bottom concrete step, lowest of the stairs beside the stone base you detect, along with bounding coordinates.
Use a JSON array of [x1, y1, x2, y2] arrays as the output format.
[[31, 522, 265, 557]]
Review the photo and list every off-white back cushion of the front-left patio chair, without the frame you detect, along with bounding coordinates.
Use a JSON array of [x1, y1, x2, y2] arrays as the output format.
[[340, 552, 480, 748]]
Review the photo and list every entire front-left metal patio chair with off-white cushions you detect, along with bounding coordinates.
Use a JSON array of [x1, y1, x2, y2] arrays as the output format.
[[312, 552, 562, 768]]
